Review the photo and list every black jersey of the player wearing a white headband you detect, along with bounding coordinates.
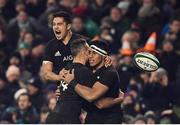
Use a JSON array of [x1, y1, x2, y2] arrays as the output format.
[[86, 67, 122, 124]]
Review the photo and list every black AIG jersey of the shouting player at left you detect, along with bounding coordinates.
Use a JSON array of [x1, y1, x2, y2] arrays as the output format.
[[43, 33, 89, 73]]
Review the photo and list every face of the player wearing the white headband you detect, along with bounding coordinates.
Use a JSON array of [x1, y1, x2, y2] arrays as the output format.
[[89, 50, 104, 67]]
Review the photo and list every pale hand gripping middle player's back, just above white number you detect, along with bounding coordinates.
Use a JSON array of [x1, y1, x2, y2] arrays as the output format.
[[59, 69, 74, 84]]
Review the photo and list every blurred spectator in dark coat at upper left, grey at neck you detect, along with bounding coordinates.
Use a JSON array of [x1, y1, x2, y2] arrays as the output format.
[[7, 10, 46, 50]]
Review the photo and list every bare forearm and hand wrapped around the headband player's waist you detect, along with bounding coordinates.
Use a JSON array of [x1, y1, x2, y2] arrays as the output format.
[[95, 91, 124, 109]]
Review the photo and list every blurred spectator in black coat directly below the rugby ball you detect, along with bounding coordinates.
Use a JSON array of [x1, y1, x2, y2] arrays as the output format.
[[142, 68, 170, 113]]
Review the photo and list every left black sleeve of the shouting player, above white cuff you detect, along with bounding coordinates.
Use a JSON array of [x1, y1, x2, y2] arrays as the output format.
[[43, 43, 54, 62]]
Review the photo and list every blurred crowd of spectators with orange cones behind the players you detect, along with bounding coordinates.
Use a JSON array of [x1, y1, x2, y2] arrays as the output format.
[[0, 0, 180, 124]]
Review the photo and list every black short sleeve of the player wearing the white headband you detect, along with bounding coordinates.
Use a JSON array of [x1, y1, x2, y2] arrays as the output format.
[[98, 72, 118, 88]]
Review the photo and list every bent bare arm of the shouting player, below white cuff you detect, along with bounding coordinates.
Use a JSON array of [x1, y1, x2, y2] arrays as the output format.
[[42, 61, 60, 81]]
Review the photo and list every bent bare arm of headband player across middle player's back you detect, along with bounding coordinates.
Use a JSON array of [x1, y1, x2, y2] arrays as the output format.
[[75, 81, 109, 102]]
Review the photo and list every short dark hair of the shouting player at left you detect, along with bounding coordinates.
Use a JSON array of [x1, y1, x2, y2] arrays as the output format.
[[52, 11, 72, 24]]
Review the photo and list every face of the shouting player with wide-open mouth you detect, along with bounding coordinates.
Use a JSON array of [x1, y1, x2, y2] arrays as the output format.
[[52, 17, 69, 40]]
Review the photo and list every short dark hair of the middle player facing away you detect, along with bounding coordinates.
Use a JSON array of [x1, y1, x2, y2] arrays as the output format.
[[70, 39, 87, 57]]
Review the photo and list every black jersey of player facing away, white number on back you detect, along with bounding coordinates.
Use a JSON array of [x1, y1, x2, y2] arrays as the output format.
[[57, 63, 96, 124]]
